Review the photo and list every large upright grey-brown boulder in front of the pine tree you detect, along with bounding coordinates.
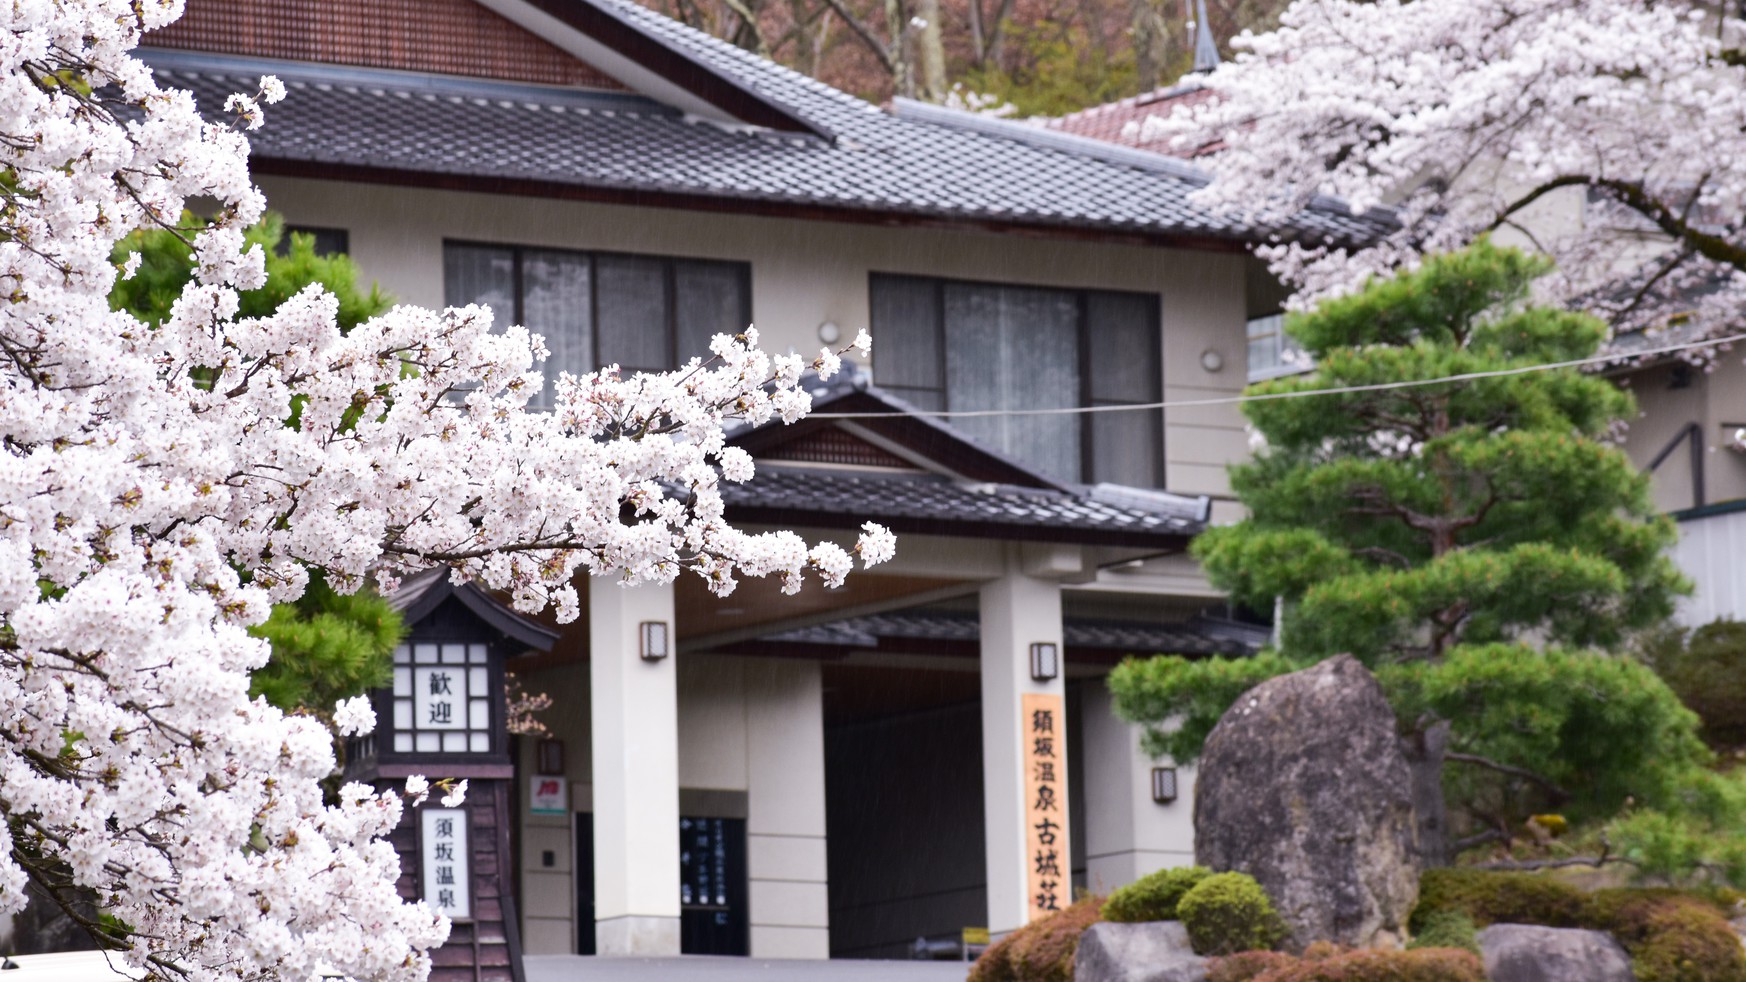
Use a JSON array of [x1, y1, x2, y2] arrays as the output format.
[[1194, 655, 1419, 951]]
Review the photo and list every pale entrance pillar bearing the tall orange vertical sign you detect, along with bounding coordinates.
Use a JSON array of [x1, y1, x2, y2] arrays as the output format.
[[980, 550, 1072, 935]]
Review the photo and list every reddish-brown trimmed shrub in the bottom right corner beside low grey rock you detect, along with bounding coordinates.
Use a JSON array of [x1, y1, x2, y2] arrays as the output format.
[[1585, 889, 1746, 982]]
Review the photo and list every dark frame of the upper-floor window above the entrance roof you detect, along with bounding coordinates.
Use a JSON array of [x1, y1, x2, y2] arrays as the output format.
[[868, 269, 1168, 489]]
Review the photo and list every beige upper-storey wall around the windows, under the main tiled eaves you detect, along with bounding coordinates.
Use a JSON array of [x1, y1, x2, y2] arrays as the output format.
[[260, 176, 1255, 493]]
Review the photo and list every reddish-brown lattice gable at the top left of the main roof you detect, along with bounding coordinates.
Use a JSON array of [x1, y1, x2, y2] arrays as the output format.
[[145, 0, 623, 91]]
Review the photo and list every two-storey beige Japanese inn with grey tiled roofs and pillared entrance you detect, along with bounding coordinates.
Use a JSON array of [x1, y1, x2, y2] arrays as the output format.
[[143, 0, 1374, 979]]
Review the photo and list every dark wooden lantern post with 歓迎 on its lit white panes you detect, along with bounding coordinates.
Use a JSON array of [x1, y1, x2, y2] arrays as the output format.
[[346, 570, 557, 979]]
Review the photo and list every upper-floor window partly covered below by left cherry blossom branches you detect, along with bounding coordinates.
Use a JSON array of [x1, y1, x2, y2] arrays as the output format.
[[443, 243, 751, 407]]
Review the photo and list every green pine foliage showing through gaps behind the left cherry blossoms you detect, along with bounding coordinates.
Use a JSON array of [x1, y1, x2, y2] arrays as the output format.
[[110, 211, 405, 716]]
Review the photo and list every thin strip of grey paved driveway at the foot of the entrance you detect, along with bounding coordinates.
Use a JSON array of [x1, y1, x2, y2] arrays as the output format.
[[524, 954, 969, 982]]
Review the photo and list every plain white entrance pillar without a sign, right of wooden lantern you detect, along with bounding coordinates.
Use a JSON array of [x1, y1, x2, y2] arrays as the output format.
[[588, 580, 679, 956]]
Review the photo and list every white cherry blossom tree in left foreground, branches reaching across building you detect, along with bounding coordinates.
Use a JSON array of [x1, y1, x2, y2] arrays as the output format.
[[0, 0, 892, 980]]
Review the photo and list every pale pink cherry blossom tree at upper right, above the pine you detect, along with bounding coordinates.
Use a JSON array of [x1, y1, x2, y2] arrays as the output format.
[[1145, 0, 1746, 354]]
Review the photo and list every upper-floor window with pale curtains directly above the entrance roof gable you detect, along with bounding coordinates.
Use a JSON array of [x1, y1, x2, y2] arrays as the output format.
[[870, 273, 1165, 488]]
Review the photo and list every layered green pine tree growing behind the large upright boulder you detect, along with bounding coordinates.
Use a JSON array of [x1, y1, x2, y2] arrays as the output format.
[[1110, 241, 1708, 859]]
